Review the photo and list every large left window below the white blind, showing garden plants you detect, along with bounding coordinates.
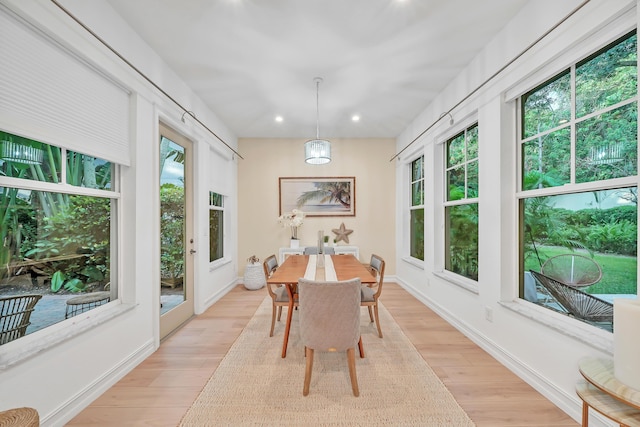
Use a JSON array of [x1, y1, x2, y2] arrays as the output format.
[[0, 131, 119, 342]]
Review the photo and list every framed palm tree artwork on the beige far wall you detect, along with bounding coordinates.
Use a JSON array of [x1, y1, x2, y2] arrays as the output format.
[[279, 176, 356, 216]]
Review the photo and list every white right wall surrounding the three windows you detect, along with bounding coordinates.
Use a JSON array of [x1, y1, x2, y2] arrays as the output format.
[[396, 0, 637, 425]]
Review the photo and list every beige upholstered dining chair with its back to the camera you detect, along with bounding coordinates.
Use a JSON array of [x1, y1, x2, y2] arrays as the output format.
[[298, 278, 361, 396]]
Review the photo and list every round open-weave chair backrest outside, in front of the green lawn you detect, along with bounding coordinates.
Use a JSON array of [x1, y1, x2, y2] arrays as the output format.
[[540, 254, 602, 287]]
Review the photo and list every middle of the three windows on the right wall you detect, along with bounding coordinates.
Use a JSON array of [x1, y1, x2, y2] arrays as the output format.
[[444, 124, 478, 280]]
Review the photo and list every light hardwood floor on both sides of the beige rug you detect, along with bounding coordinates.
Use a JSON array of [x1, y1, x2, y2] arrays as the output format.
[[68, 283, 578, 427]]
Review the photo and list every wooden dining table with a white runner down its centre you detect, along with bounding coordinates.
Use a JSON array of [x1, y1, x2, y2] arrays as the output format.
[[267, 255, 376, 357]]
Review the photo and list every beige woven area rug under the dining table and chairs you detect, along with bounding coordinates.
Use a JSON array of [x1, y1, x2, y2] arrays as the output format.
[[181, 297, 474, 427]]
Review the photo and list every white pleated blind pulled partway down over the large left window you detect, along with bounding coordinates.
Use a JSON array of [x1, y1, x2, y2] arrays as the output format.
[[0, 5, 130, 165]]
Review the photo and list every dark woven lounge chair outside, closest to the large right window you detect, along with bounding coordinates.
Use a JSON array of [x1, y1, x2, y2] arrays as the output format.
[[531, 271, 613, 328]]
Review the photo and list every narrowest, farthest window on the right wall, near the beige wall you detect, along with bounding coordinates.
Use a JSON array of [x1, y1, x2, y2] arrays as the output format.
[[409, 156, 424, 261]]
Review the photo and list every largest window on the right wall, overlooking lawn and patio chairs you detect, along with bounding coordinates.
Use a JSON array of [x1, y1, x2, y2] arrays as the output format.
[[519, 31, 638, 330]]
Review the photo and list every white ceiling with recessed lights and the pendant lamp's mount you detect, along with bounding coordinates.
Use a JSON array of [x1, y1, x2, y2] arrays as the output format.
[[102, 0, 527, 138]]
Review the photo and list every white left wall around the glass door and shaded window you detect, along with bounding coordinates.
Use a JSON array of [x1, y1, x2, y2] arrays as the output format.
[[0, 0, 237, 426]]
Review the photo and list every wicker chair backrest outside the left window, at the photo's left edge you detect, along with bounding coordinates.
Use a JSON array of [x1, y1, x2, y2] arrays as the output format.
[[0, 295, 42, 345]]
